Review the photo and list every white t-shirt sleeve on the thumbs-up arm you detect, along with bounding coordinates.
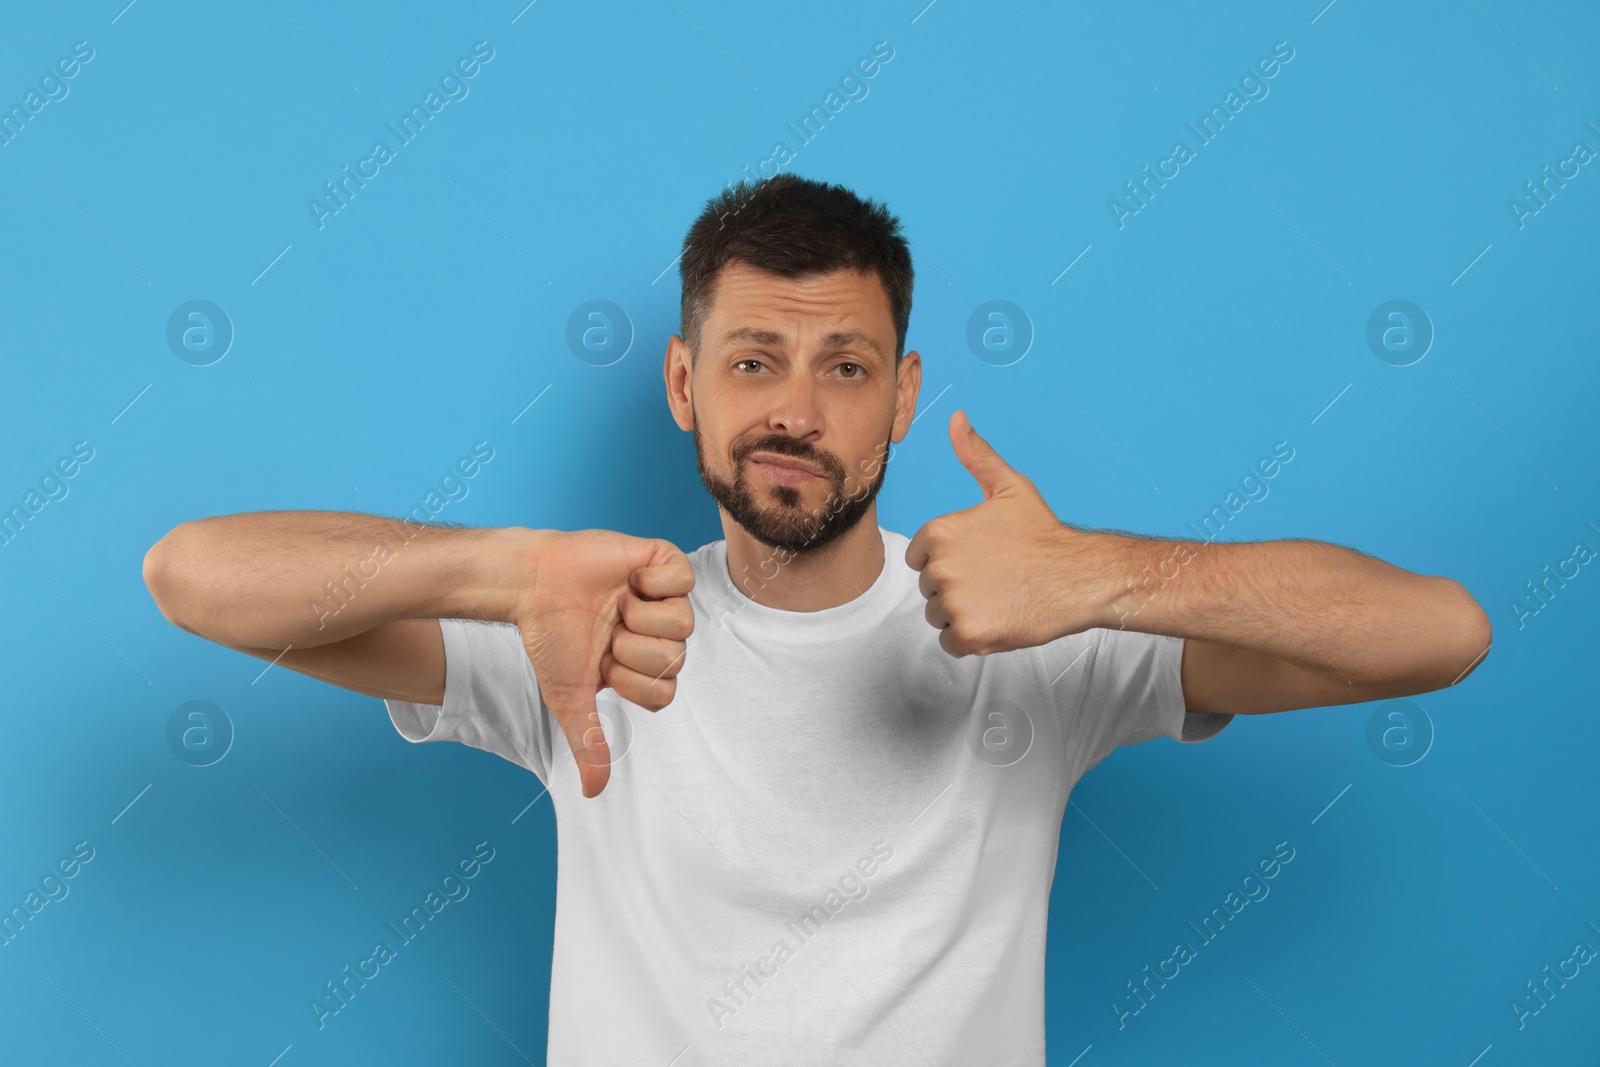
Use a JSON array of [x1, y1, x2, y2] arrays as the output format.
[[1043, 627, 1234, 773]]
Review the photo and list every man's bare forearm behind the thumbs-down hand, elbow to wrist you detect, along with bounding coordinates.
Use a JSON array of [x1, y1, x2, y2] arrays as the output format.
[[144, 512, 517, 648]]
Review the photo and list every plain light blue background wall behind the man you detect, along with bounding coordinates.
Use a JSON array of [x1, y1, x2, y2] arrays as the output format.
[[0, 0, 1600, 1067]]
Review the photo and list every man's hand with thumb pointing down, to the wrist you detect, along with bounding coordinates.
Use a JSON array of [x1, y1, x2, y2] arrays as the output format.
[[512, 530, 694, 797]]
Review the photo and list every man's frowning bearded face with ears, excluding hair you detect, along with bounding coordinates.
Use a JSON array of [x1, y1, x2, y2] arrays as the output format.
[[669, 261, 920, 555]]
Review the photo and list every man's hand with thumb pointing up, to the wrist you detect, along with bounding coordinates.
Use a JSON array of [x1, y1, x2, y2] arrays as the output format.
[[906, 411, 1117, 659]]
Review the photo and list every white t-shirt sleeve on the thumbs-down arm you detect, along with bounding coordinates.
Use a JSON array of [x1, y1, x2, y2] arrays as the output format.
[[384, 619, 550, 785]]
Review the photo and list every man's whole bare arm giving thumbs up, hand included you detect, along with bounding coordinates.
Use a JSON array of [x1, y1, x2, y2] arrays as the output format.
[[906, 411, 1493, 713]]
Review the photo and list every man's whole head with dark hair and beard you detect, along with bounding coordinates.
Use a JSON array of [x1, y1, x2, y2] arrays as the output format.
[[666, 174, 922, 553]]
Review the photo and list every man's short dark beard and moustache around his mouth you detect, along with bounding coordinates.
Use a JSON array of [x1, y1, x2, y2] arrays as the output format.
[[694, 419, 890, 557]]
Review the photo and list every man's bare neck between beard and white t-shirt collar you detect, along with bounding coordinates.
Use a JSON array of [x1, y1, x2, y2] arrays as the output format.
[[722, 501, 888, 611]]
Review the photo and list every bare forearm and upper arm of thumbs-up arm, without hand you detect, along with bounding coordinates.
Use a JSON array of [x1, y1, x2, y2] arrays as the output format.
[[1100, 531, 1493, 713]]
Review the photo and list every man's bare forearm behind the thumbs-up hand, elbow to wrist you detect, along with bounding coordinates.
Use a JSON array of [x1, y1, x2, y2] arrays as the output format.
[[1104, 536, 1490, 691]]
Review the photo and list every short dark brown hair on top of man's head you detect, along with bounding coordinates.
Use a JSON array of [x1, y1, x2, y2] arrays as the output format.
[[678, 173, 912, 368]]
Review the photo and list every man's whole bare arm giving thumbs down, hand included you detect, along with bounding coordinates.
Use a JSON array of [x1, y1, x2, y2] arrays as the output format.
[[144, 512, 694, 797]]
